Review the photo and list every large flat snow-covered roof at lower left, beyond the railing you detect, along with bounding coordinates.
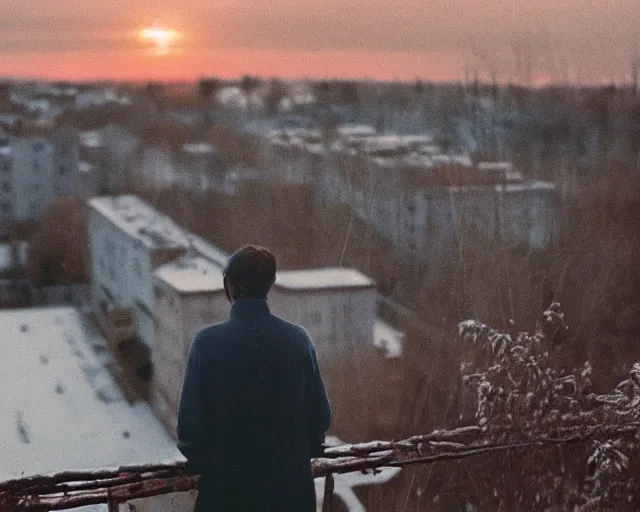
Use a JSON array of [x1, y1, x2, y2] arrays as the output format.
[[0, 308, 180, 481]]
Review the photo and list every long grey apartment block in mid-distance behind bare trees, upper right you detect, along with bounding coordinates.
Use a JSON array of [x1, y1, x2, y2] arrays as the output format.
[[268, 126, 559, 287]]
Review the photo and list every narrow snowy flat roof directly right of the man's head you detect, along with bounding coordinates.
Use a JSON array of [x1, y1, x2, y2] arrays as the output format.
[[275, 268, 375, 291]]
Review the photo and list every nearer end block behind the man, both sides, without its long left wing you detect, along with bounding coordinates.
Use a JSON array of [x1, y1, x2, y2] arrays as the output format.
[[151, 260, 388, 439]]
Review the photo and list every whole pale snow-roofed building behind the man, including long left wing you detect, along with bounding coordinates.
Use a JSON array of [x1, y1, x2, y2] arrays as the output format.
[[88, 196, 392, 441]]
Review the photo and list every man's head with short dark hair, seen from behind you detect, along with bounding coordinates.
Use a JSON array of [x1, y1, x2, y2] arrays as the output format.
[[223, 245, 276, 299]]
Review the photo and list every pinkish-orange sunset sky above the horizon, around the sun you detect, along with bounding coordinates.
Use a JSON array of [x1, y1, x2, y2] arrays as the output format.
[[0, 0, 640, 83]]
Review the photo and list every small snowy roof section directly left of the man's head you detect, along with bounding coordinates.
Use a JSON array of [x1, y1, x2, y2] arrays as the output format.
[[154, 256, 224, 293]]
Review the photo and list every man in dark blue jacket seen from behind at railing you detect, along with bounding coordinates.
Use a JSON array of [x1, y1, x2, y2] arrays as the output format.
[[178, 246, 331, 512]]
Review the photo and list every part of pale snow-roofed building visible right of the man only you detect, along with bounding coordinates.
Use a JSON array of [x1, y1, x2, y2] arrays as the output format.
[[269, 268, 379, 441]]
